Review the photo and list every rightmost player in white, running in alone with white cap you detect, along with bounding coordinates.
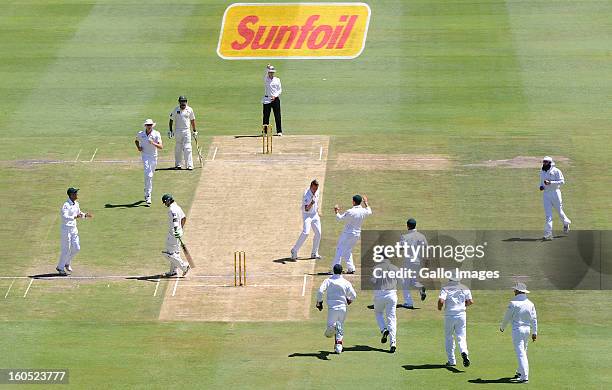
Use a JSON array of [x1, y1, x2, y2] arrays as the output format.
[[540, 156, 572, 240]]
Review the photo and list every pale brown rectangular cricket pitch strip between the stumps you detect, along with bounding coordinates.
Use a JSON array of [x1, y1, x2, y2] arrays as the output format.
[[159, 136, 329, 321]]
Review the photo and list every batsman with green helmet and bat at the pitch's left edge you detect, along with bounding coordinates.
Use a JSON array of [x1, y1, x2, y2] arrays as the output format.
[[162, 194, 189, 277]]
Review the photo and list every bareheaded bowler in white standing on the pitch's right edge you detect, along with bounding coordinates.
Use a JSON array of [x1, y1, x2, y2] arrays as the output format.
[[291, 179, 321, 260]]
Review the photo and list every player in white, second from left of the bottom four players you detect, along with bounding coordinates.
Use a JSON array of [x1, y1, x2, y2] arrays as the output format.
[[372, 259, 400, 353]]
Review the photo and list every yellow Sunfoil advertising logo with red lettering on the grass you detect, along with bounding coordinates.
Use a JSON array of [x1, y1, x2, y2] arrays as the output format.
[[217, 3, 370, 60]]
